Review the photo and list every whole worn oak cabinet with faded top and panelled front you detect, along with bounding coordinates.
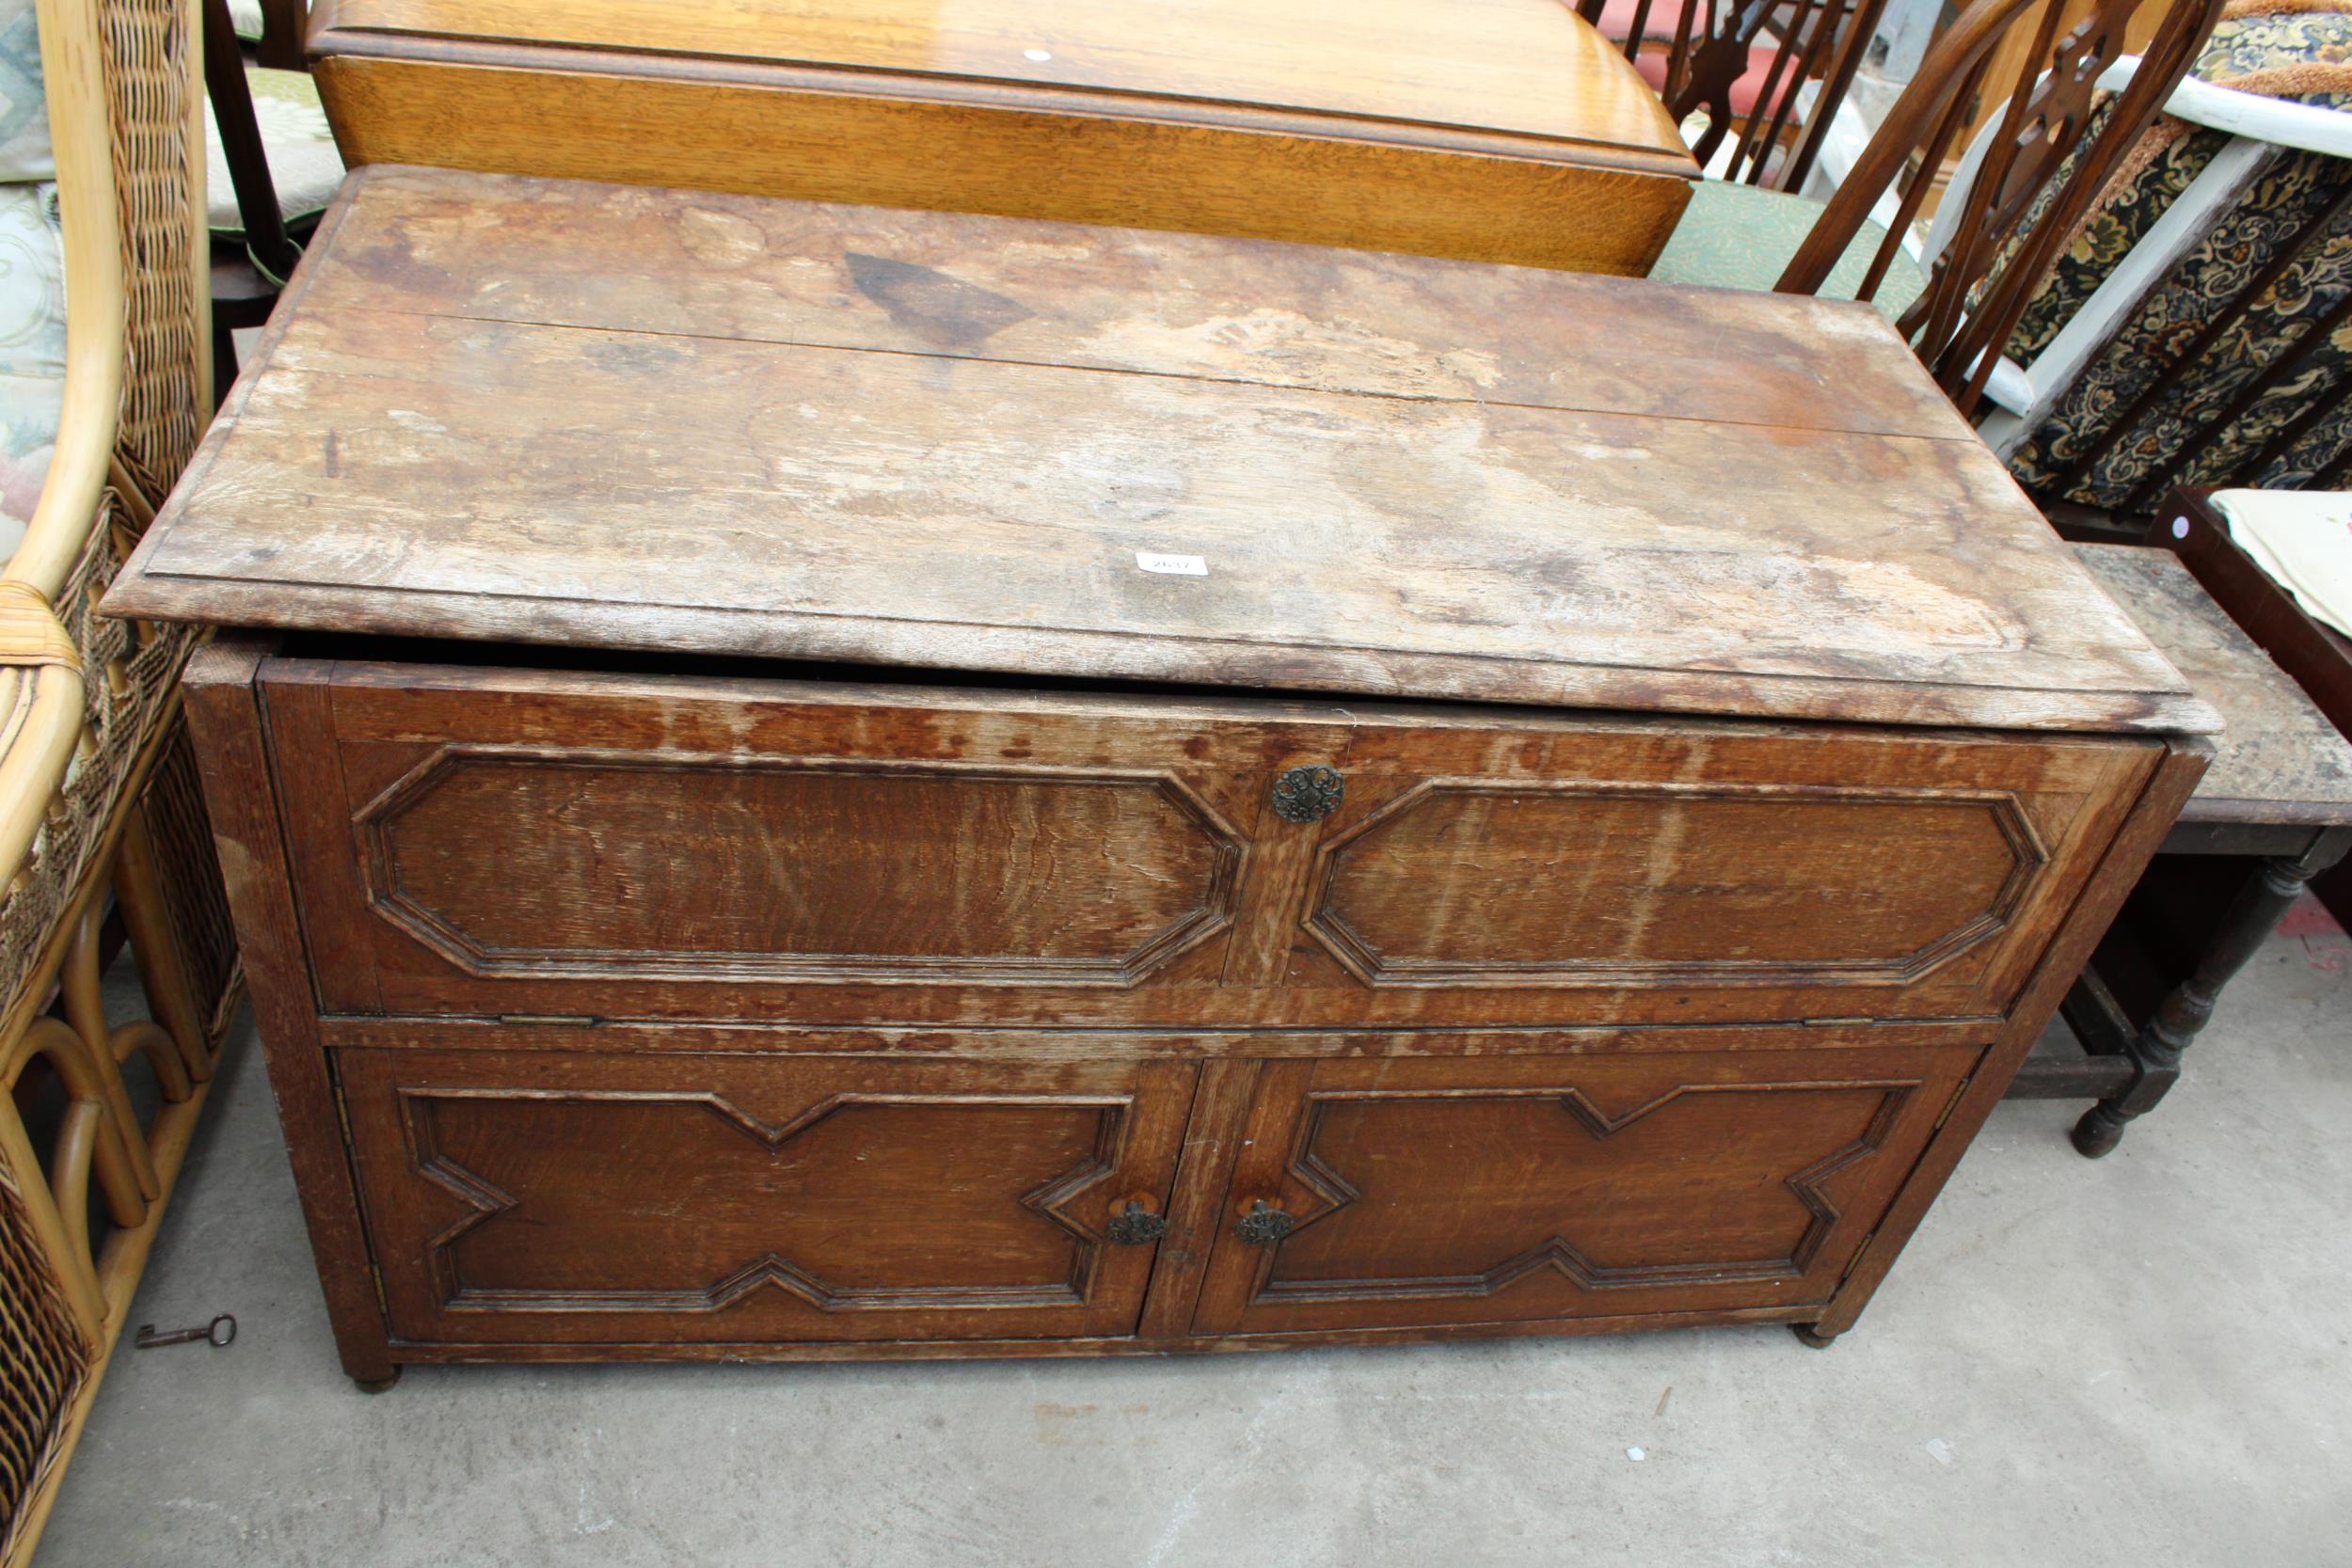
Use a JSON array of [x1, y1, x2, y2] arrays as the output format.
[[106, 168, 2214, 1387]]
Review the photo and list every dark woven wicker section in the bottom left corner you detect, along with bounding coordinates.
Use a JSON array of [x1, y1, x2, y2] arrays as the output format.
[[0, 1151, 89, 1559]]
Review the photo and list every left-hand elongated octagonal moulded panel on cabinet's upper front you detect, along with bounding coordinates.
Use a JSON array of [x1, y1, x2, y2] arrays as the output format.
[[358, 745, 1245, 985]]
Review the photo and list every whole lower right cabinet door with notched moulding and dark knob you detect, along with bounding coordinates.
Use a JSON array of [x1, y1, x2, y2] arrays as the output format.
[[1195, 1046, 1979, 1336]]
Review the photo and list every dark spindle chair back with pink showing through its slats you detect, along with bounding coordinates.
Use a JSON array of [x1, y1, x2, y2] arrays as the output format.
[[1576, 0, 1886, 190]]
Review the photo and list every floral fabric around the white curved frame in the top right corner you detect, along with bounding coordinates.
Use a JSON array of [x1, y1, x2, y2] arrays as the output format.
[[2009, 0, 2352, 510]]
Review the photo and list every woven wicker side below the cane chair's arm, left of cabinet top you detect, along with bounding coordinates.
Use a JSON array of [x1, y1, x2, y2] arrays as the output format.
[[0, 510, 193, 999]]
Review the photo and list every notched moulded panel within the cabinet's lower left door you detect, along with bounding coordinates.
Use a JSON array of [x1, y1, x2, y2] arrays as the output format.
[[400, 1088, 1129, 1314]]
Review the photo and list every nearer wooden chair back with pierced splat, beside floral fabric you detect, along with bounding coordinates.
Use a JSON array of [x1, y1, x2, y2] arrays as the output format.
[[1776, 0, 2223, 414]]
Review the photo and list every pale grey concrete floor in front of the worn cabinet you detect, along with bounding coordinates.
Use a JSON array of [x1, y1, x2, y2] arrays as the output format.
[[38, 911, 2352, 1568]]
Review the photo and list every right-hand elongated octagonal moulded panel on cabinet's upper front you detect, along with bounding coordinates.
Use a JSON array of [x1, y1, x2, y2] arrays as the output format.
[[1306, 778, 2046, 985]]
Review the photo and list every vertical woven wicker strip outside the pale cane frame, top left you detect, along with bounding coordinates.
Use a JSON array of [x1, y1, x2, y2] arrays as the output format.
[[99, 0, 212, 505]]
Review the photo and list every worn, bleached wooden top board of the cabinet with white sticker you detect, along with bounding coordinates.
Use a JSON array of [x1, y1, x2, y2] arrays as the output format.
[[106, 169, 2214, 731]]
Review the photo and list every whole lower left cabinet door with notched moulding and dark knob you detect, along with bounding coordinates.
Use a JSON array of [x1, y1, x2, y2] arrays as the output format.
[[339, 1051, 1195, 1345]]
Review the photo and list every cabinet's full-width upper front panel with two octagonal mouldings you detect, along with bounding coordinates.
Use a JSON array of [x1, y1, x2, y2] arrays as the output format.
[[263, 658, 2154, 1032]]
